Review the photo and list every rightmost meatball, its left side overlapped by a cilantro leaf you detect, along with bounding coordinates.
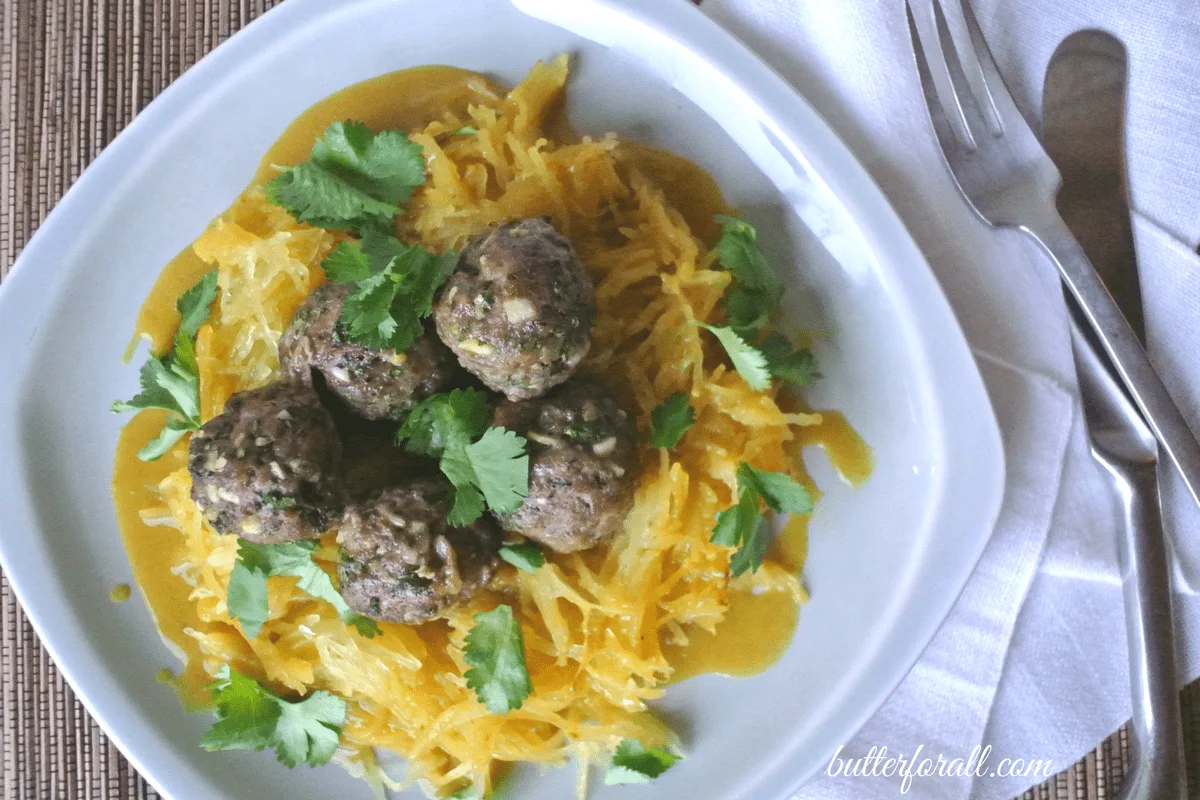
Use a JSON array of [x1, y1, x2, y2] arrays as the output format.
[[493, 378, 637, 553]]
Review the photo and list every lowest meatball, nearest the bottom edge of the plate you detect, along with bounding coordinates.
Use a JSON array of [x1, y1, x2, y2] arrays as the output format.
[[337, 479, 500, 625]]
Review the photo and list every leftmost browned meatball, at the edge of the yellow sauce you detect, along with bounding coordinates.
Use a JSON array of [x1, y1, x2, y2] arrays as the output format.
[[187, 384, 342, 545]]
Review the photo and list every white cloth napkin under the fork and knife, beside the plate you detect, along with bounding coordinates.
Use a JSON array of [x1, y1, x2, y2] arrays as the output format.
[[701, 0, 1200, 800]]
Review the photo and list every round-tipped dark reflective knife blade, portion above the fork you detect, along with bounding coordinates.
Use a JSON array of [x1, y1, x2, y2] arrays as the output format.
[[1042, 30, 1146, 345]]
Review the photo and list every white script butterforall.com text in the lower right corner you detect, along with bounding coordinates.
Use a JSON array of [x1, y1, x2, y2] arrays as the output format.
[[826, 745, 1051, 794]]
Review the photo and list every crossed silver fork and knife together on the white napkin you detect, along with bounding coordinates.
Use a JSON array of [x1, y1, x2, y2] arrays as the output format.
[[907, 0, 1200, 800]]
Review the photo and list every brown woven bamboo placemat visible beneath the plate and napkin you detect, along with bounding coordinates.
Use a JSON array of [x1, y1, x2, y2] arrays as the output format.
[[0, 0, 1200, 800]]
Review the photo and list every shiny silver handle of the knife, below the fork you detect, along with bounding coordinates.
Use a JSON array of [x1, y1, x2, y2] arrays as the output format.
[[1092, 447, 1188, 800]]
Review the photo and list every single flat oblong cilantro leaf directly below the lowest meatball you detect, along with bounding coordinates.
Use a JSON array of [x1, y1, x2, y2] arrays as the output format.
[[463, 606, 533, 714]]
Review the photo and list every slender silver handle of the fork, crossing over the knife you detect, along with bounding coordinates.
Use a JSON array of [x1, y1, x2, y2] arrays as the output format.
[[1021, 213, 1200, 505]]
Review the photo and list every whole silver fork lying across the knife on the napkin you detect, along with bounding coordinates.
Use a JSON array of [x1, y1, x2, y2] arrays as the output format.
[[906, 0, 1200, 513]]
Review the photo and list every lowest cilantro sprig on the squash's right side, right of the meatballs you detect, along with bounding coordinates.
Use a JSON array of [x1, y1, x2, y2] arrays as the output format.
[[712, 462, 812, 577]]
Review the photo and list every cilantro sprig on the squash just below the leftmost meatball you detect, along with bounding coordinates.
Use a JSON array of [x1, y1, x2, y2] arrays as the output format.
[[226, 540, 379, 638]]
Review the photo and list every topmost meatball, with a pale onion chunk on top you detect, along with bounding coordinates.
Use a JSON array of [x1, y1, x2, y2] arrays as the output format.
[[433, 219, 595, 401]]
